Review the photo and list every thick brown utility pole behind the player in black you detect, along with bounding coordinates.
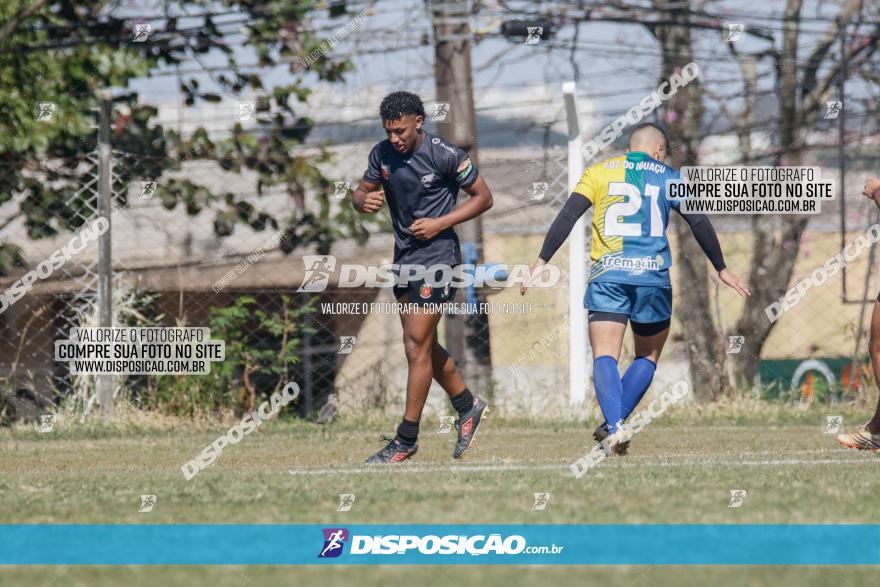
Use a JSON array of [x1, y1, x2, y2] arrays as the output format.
[[427, 0, 492, 399]]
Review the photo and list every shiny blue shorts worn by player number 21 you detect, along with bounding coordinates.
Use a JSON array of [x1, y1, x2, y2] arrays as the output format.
[[584, 281, 672, 324]]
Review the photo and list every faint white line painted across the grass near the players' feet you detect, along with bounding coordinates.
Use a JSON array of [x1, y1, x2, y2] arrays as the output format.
[[288, 449, 877, 475]]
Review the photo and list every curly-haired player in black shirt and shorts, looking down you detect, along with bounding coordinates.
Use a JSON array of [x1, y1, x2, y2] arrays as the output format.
[[353, 92, 492, 463]]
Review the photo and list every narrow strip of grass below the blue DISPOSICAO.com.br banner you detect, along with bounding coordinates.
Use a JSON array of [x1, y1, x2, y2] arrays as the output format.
[[0, 566, 877, 587]]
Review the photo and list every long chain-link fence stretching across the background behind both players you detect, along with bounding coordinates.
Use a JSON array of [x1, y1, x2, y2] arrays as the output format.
[[0, 112, 880, 417]]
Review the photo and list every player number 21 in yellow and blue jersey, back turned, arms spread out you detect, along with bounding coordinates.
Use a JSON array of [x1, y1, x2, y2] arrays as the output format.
[[522, 123, 749, 454]]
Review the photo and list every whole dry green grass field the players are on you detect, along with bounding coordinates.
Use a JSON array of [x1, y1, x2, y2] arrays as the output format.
[[0, 407, 880, 586]]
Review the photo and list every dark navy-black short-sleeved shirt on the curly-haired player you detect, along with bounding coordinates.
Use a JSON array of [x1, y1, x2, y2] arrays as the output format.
[[364, 131, 479, 267]]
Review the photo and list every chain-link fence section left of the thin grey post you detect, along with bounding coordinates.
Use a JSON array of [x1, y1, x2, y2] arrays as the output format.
[[0, 152, 126, 417]]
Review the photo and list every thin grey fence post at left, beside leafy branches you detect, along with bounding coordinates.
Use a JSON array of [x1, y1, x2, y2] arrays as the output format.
[[95, 90, 113, 422]]
